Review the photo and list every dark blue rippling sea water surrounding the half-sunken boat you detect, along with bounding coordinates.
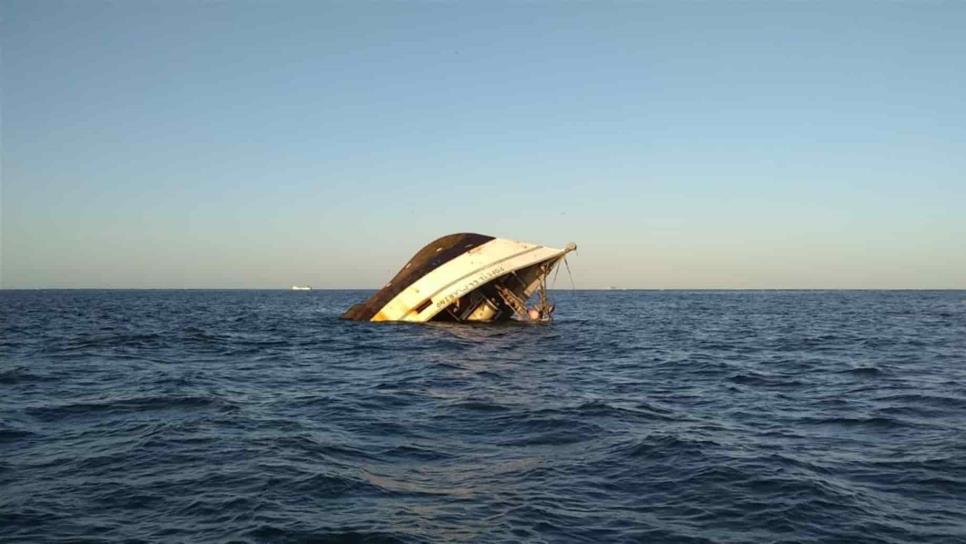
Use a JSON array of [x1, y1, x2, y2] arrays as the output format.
[[0, 291, 966, 543]]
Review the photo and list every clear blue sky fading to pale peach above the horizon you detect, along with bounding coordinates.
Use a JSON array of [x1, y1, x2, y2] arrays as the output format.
[[0, 0, 966, 288]]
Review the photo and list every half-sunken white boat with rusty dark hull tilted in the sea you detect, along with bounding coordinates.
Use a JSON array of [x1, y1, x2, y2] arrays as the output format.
[[342, 232, 577, 322]]
